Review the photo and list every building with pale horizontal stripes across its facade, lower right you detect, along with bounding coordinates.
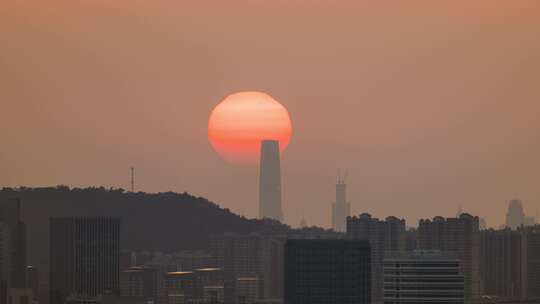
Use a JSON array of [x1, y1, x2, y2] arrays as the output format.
[[384, 250, 465, 304]]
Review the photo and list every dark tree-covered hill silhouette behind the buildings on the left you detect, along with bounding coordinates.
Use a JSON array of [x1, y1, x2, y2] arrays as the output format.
[[0, 186, 289, 265]]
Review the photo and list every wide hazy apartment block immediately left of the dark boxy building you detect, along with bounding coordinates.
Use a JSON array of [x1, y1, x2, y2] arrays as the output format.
[[211, 234, 285, 303]]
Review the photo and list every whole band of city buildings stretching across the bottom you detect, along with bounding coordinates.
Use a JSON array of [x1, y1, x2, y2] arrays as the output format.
[[0, 190, 540, 304]]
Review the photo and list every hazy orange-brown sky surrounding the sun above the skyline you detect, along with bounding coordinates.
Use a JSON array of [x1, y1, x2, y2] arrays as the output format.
[[0, 0, 540, 227]]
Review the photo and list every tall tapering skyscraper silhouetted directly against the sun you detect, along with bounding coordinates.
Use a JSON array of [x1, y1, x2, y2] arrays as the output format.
[[259, 140, 283, 221]]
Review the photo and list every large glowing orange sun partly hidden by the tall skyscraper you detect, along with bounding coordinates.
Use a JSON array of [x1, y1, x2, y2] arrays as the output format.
[[208, 92, 292, 164]]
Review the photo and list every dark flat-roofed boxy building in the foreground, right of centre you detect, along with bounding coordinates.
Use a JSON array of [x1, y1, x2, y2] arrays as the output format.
[[284, 239, 371, 304]]
